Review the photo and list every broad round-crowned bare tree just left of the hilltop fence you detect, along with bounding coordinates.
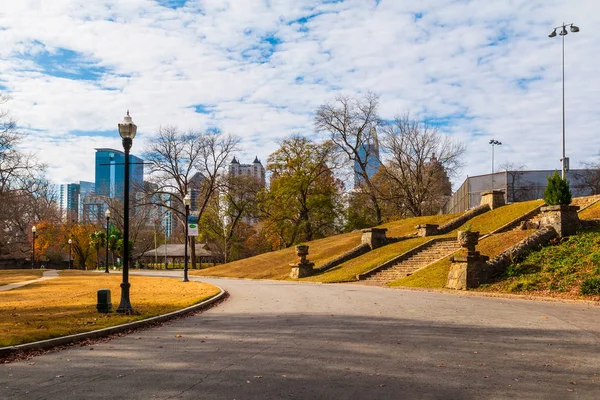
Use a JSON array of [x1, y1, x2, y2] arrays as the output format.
[[380, 114, 465, 216]]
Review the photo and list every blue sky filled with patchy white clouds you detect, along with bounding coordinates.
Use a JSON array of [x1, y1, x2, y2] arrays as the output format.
[[0, 0, 600, 187]]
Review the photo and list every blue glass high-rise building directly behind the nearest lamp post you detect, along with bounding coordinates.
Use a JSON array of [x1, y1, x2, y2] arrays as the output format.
[[96, 148, 144, 201]]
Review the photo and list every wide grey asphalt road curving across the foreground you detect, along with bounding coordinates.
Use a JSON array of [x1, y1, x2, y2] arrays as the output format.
[[0, 279, 600, 399]]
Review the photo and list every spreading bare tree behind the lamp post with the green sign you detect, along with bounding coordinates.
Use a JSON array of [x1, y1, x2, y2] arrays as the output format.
[[144, 127, 239, 268]]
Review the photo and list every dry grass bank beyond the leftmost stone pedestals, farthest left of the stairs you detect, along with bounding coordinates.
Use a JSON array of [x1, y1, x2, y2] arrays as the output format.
[[190, 214, 457, 279]]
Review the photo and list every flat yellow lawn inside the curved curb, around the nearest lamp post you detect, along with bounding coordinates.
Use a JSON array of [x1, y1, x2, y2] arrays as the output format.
[[0, 271, 219, 347]]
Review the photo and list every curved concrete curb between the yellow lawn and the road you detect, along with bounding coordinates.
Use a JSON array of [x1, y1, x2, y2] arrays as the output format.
[[0, 286, 227, 358]]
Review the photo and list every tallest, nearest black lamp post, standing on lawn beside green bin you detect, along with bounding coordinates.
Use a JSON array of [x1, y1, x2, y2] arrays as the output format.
[[117, 110, 137, 314]]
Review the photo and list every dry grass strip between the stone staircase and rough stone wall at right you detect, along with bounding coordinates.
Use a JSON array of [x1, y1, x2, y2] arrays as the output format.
[[389, 230, 534, 288]]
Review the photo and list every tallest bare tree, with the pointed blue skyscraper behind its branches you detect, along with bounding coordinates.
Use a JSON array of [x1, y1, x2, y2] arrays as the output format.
[[315, 92, 382, 224]]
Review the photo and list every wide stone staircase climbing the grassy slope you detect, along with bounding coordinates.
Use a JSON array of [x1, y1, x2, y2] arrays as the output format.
[[365, 240, 460, 283]]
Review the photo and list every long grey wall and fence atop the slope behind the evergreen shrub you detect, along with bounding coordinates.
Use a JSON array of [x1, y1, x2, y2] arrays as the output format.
[[442, 169, 592, 214]]
